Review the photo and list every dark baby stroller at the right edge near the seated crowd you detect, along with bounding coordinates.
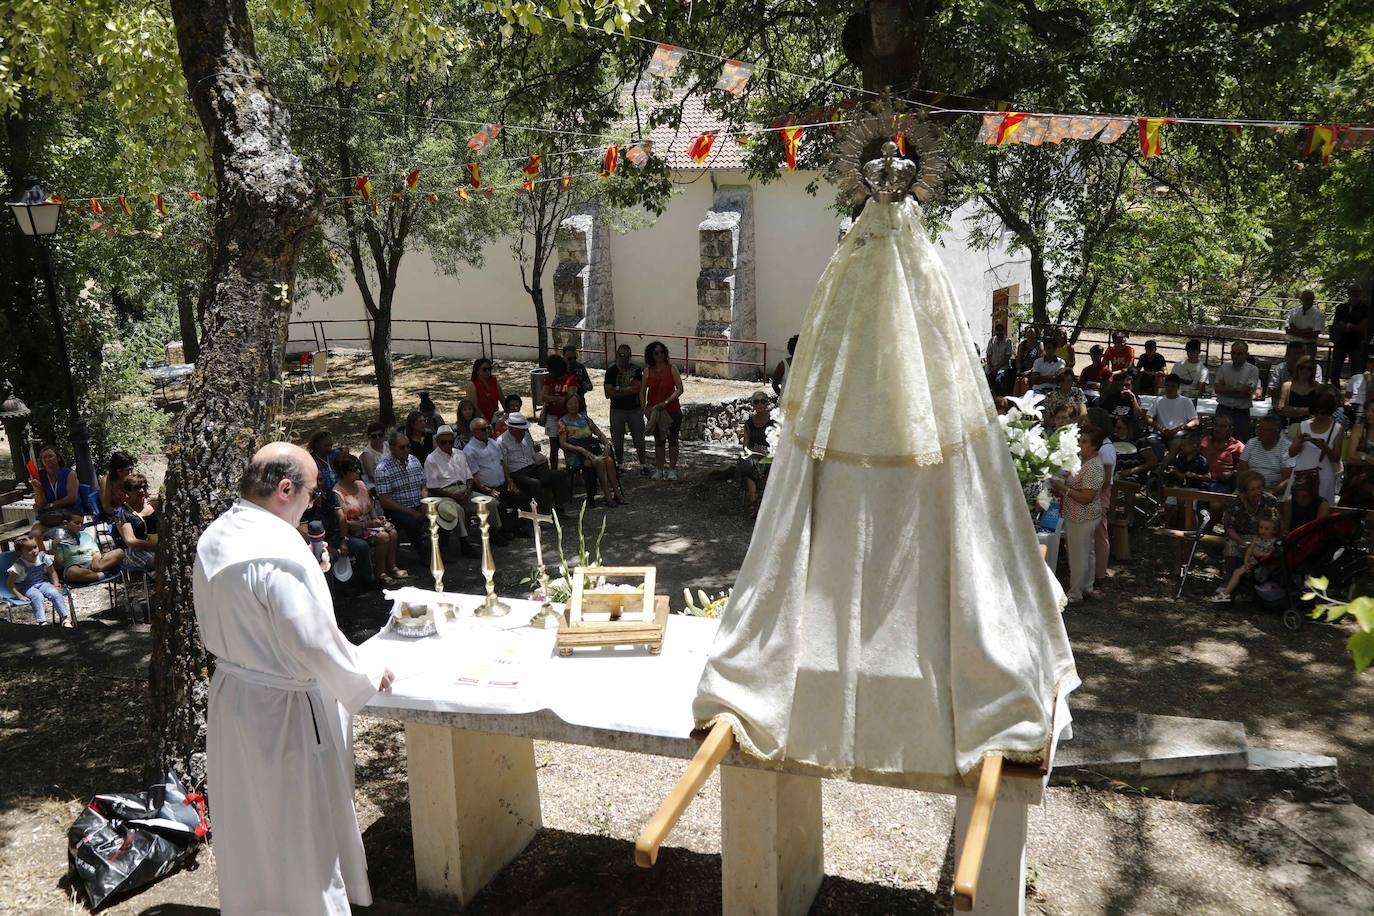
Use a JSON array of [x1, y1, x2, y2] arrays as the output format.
[[1254, 512, 1369, 630]]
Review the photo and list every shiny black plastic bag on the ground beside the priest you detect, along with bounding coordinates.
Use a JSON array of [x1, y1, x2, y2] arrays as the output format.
[[67, 772, 210, 909]]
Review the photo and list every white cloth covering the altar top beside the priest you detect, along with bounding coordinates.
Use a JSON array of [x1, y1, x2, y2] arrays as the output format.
[[360, 589, 717, 737]]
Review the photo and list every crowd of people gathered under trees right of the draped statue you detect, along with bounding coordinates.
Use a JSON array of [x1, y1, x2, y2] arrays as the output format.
[[985, 318, 1374, 602]]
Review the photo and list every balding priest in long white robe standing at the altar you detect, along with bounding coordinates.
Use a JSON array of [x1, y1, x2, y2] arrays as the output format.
[[195, 442, 392, 916]]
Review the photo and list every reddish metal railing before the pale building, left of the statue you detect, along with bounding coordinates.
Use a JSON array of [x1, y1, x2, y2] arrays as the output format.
[[286, 317, 771, 379]]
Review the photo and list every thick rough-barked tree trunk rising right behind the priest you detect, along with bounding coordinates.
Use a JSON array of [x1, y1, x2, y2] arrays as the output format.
[[150, 0, 320, 786]]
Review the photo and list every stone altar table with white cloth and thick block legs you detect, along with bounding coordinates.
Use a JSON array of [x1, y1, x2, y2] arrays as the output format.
[[360, 589, 1044, 916]]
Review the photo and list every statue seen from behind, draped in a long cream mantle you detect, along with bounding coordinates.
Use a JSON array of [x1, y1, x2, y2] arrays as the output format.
[[692, 135, 1079, 781]]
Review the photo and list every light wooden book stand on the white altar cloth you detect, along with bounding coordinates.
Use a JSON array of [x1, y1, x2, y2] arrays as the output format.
[[558, 566, 668, 656]]
